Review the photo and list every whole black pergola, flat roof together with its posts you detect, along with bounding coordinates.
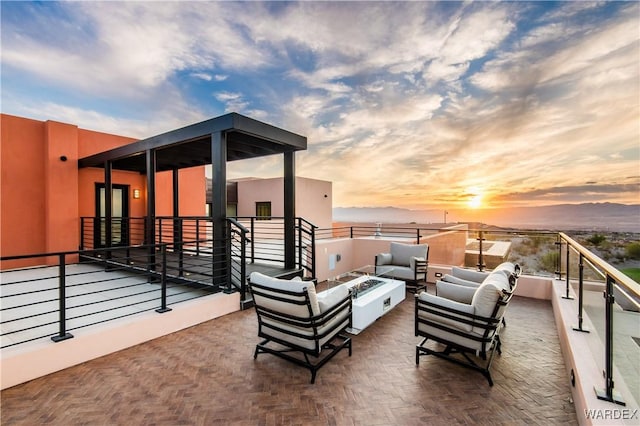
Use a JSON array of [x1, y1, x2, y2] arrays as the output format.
[[78, 113, 307, 284]]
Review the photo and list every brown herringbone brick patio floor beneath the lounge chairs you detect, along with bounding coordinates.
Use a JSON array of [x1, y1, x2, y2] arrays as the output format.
[[0, 295, 577, 425]]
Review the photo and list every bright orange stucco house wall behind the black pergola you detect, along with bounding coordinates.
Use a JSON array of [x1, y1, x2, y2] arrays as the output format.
[[0, 114, 206, 269]]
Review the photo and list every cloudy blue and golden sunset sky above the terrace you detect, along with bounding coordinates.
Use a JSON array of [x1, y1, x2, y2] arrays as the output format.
[[1, 2, 640, 209]]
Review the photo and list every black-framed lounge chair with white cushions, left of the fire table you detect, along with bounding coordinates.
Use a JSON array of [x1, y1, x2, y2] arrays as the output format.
[[249, 272, 351, 383]]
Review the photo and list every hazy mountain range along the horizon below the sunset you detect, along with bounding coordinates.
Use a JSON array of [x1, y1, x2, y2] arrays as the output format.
[[333, 203, 640, 232]]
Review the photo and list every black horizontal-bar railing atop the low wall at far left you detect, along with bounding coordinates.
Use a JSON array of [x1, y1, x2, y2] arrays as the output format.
[[0, 244, 221, 348]]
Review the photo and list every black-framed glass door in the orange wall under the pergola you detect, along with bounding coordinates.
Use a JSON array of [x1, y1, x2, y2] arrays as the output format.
[[94, 183, 129, 247]]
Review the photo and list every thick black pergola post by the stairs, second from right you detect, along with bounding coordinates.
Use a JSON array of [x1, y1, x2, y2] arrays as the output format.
[[211, 132, 231, 286]]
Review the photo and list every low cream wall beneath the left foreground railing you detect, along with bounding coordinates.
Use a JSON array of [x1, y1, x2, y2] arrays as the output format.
[[0, 292, 240, 389]]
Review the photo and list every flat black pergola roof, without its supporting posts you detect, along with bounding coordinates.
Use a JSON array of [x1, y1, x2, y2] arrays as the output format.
[[78, 113, 307, 173]]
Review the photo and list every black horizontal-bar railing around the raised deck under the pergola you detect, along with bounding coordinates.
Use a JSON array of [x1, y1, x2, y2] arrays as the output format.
[[80, 216, 317, 300]]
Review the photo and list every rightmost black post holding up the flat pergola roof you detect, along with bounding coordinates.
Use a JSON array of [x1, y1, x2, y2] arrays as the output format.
[[284, 151, 296, 269]]
